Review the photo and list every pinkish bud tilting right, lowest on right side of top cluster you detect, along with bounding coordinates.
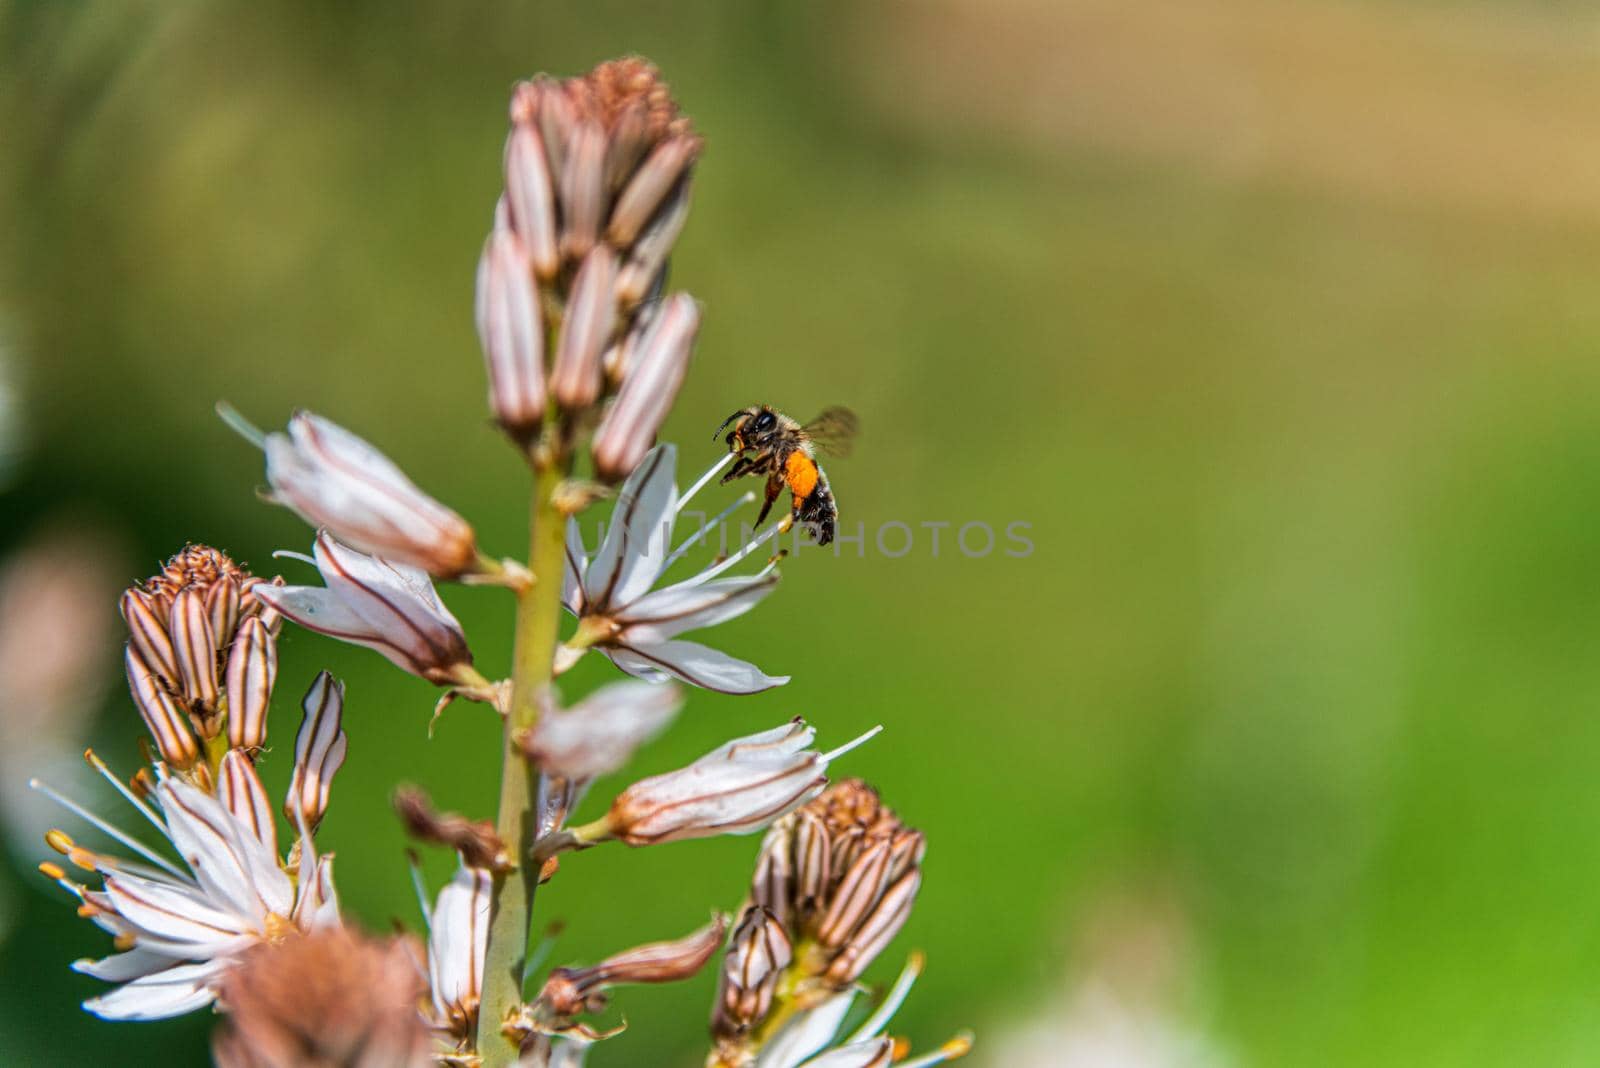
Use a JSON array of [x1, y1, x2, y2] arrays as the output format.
[[594, 293, 699, 481]]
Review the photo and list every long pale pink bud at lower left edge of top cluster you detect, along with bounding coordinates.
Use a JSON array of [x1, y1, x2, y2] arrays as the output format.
[[477, 225, 544, 444]]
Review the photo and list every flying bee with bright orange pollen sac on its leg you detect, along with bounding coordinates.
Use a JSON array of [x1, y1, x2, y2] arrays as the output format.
[[712, 404, 859, 545]]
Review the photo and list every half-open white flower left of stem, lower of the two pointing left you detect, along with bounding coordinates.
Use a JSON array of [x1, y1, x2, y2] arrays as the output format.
[[256, 531, 472, 684]]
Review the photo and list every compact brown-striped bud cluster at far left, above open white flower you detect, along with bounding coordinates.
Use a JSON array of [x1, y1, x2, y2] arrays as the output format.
[[122, 545, 280, 771]]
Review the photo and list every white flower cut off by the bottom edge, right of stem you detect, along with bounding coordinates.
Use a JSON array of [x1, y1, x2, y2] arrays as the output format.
[[754, 954, 973, 1068]]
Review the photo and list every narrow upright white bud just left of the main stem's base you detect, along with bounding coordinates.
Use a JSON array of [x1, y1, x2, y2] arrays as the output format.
[[426, 863, 494, 1042]]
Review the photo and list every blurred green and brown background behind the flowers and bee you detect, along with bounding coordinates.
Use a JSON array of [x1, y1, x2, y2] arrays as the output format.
[[0, 0, 1600, 1066]]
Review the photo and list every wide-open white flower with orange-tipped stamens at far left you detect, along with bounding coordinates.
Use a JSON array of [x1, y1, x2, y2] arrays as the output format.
[[32, 750, 339, 1020]]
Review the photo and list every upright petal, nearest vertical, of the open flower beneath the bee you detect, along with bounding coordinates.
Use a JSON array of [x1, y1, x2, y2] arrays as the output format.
[[584, 444, 678, 614]]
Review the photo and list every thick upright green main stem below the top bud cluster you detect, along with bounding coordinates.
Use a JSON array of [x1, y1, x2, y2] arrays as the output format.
[[478, 464, 566, 1068]]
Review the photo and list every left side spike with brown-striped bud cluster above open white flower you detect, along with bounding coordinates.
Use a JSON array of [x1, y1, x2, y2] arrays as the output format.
[[30, 545, 358, 1020]]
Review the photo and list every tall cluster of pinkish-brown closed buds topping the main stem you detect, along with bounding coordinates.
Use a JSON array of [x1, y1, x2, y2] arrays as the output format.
[[477, 58, 701, 480]]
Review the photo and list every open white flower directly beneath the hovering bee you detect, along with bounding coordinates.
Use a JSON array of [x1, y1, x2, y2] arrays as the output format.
[[557, 444, 789, 694]]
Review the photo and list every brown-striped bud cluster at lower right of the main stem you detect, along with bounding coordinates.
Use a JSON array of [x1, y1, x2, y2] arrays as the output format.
[[712, 779, 923, 1041]]
